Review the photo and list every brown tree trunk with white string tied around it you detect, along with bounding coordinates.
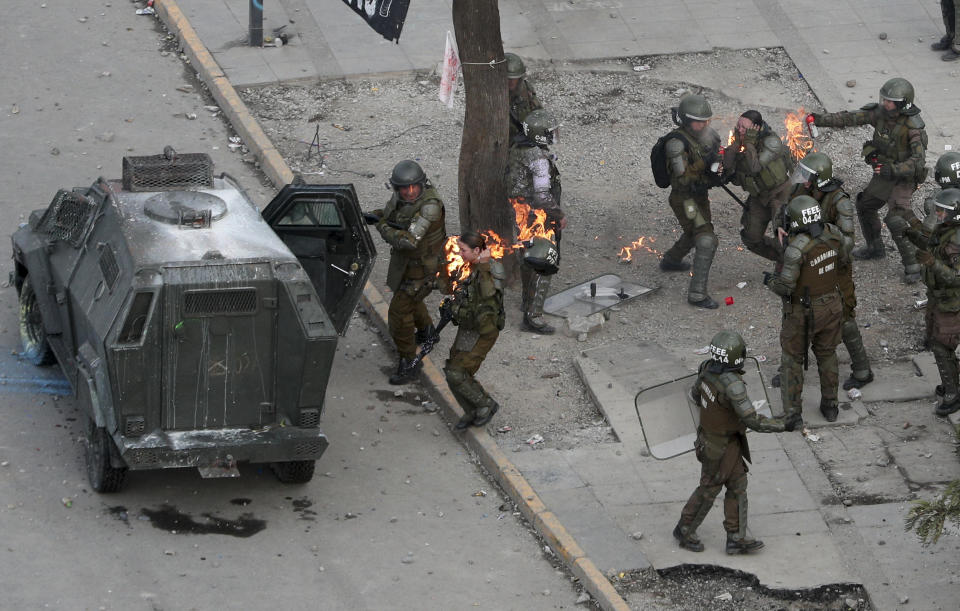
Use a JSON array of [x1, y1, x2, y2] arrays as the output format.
[[453, 0, 514, 268]]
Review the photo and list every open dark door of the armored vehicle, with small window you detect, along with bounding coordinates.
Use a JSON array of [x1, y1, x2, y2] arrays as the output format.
[[263, 184, 376, 335]]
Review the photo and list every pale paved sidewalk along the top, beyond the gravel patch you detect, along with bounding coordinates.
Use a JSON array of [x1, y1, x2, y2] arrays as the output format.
[[179, 0, 960, 154]]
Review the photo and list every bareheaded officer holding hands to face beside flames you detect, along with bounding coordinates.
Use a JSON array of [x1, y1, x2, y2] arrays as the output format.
[[723, 110, 793, 261]]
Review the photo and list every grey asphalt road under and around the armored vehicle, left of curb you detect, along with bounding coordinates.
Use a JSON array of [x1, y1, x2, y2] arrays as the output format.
[[0, 0, 577, 609]]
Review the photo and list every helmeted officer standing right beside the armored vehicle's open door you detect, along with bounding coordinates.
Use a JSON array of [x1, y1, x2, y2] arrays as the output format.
[[373, 159, 447, 384]]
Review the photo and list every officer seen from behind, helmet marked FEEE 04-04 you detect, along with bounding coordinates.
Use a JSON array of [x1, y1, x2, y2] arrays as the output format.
[[764, 195, 850, 427]]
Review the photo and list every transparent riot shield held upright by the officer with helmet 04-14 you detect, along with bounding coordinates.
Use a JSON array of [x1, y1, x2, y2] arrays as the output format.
[[633, 357, 772, 460]]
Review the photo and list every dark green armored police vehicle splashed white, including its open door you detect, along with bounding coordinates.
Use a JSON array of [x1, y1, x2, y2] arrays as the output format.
[[11, 147, 375, 492]]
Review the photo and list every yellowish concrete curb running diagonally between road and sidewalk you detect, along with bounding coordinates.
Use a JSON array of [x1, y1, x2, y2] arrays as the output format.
[[154, 0, 630, 611]]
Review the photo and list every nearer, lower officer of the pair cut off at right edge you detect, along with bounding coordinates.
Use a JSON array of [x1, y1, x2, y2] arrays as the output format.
[[907, 187, 960, 416]]
